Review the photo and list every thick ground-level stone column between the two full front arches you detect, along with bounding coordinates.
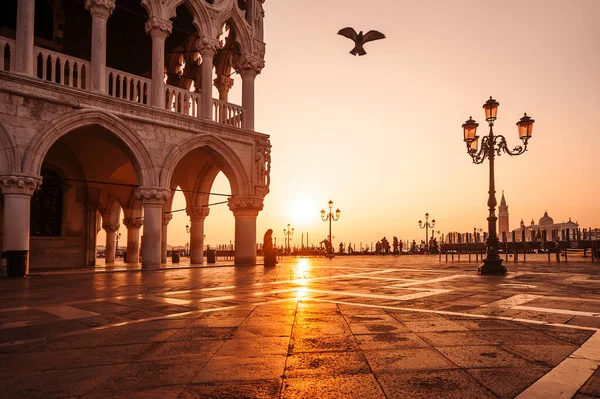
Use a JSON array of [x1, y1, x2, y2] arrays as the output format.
[[135, 187, 171, 269]]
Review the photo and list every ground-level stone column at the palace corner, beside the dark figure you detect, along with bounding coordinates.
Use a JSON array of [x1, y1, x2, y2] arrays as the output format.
[[228, 197, 263, 265]]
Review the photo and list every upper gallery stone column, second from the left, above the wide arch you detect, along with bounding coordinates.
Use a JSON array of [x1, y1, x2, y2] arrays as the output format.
[[85, 0, 115, 93]]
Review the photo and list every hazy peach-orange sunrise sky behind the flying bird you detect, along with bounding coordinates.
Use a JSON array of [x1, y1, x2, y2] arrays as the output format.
[[104, 0, 600, 247]]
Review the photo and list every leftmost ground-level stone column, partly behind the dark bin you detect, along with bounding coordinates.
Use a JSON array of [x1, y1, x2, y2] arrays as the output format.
[[0, 173, 42, 275]]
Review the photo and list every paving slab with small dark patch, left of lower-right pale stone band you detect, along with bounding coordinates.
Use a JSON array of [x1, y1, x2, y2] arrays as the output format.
[[436, 346, 535, 368]]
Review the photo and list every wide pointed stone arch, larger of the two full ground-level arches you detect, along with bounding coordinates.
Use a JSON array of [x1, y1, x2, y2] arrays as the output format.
[[22, 109, 158, 186]]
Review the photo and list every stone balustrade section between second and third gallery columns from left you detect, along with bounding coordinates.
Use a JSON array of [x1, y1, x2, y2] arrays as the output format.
[[106, 68, 152, 104]]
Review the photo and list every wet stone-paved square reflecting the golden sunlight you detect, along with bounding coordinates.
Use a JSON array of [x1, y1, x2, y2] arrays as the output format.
[[0, 256, 600, 399]]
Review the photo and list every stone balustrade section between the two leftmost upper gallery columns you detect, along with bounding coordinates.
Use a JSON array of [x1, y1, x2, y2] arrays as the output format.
[[33, 47, 91, 90]]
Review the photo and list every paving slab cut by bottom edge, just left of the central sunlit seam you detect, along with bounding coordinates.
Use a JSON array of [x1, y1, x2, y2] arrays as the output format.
[[179, 378, 281, 399]]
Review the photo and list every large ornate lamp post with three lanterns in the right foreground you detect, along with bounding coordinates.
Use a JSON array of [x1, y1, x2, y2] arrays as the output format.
[[462, 97, 535, 274]]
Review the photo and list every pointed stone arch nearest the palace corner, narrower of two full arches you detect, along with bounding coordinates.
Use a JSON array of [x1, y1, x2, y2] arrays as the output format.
[[159, 135, 252, 195]]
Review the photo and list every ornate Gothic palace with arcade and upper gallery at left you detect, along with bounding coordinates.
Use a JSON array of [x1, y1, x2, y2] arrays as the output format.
[[0, 0, 271, 269]]
